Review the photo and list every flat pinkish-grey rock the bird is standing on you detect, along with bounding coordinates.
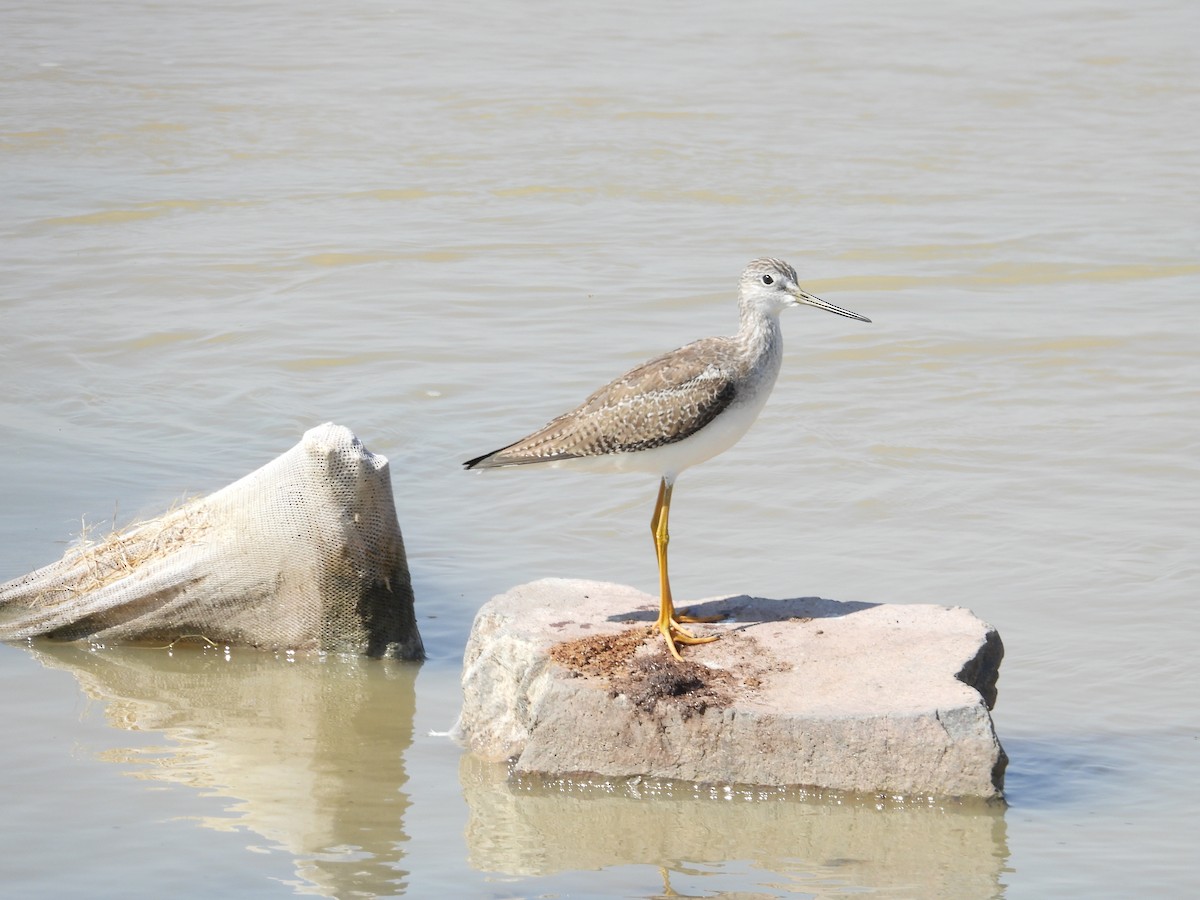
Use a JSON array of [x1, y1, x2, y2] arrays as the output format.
[[456, 578, 1007, 798]]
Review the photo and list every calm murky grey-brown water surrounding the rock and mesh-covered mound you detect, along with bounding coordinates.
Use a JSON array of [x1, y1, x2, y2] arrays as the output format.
[[0, 0, 1200, 898]]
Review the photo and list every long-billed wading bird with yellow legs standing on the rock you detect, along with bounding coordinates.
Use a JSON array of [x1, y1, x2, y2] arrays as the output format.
[[463, 258, 870, 659]]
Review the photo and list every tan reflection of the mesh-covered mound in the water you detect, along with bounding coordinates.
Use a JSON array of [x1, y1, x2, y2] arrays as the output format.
[[34, 643, 418, 898]]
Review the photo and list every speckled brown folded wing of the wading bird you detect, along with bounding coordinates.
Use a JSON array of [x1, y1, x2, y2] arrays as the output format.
[[463, 337, 737, 469]]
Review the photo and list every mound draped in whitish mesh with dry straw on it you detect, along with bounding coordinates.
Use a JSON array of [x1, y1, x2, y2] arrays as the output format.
[[0, 424, 424, 659]]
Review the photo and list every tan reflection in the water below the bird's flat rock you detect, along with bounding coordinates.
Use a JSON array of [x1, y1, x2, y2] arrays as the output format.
[[460, 754, 1008, 898]]
